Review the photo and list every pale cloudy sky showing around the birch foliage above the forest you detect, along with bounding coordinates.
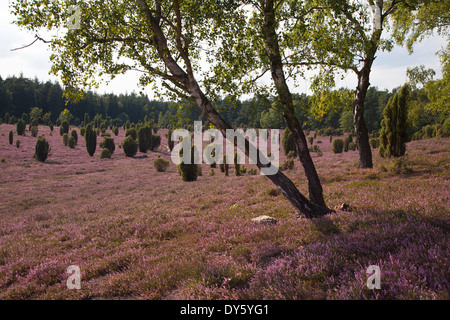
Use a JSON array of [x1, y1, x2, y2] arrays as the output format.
[[0, 0, 446, 97]]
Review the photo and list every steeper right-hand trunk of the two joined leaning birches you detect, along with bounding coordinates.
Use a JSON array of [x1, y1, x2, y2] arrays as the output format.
[[263, 0, 326, 208]]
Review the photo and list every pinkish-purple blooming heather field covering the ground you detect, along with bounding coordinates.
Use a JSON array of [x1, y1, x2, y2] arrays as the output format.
[[0, 125, 450, 299]]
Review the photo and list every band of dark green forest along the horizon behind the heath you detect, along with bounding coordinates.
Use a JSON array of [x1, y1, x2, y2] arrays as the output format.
[[0, 76, 448, 134]]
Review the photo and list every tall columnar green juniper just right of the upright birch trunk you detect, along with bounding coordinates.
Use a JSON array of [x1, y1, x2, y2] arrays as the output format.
[[378, 85, 412, 158]]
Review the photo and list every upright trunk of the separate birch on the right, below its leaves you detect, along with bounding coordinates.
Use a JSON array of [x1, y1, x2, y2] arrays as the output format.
[[353, 61, 373, 169]]
